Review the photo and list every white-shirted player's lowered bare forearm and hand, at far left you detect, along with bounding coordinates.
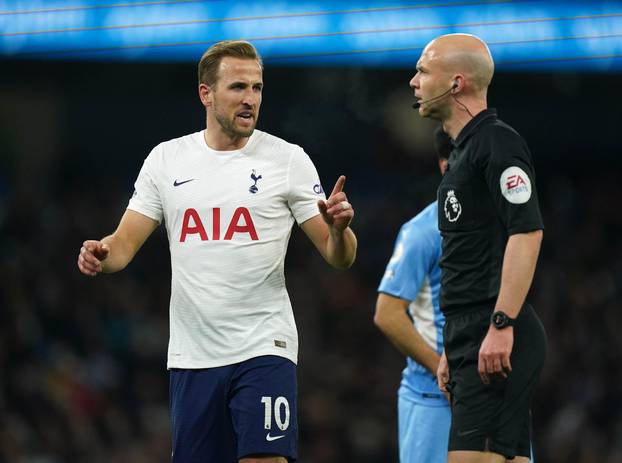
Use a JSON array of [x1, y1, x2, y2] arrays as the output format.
[[78, 210, 158, 276]]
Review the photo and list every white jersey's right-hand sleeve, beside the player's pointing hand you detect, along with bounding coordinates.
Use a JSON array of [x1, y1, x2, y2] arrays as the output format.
[[287, 148, 326, 225]]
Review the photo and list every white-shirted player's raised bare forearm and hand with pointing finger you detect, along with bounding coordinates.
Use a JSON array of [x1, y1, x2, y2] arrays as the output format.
[[301, 175, 357, 269]]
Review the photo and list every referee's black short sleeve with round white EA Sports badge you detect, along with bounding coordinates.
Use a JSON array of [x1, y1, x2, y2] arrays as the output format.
[[480, 126, 544, 235]]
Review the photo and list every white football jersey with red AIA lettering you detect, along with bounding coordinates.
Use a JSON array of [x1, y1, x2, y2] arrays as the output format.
[[128, 130, 325, 368]]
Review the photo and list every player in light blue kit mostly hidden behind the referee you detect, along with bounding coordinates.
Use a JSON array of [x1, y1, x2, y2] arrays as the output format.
[[374, 129, 452, 463]]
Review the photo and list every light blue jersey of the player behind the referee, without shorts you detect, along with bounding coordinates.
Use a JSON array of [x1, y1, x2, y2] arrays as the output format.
[[378, 201, 448, 406]]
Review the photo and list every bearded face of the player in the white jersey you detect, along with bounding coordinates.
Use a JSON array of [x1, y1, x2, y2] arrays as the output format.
[[208, 56, 263, 138]]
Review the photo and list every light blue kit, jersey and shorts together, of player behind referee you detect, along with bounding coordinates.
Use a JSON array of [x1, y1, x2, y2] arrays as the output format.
[[378, 202, 451, 463]]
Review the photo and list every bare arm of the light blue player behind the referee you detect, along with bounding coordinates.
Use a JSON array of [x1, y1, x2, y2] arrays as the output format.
[[374, 293, 440, 376]]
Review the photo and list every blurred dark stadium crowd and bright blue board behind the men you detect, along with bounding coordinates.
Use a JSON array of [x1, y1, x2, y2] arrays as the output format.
[[0, 0, 622, 463]]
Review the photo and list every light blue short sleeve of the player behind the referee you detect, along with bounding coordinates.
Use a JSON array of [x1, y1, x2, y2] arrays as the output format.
[[378, 223, 440, 301]]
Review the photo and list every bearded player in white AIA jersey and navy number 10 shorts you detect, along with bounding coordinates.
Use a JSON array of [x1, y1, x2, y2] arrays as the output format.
[[78, 41, 356, 463]]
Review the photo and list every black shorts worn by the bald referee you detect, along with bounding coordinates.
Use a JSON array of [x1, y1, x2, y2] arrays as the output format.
[[444, 304, 546, 458]]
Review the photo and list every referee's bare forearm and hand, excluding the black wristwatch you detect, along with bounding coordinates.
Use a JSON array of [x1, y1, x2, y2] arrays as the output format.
[[478, 230, 543, 384]]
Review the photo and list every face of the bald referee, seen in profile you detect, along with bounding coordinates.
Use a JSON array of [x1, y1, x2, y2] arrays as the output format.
[[410, 44, 451, 119]]
